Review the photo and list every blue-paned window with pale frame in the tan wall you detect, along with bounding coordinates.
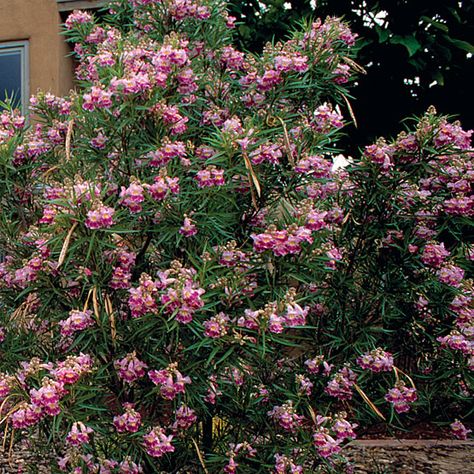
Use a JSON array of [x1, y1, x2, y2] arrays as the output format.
[[0, 41, 29, 114]]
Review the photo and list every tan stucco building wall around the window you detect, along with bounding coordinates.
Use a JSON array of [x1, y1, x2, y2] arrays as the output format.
[[0, 0, 73, 95]]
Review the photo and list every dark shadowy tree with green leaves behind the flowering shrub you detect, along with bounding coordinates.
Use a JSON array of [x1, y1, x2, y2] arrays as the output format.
[[228, 0, 474, 152]]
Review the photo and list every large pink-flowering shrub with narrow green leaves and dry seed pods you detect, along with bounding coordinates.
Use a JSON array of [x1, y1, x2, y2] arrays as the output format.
[[0, 0, 474, 473]]
